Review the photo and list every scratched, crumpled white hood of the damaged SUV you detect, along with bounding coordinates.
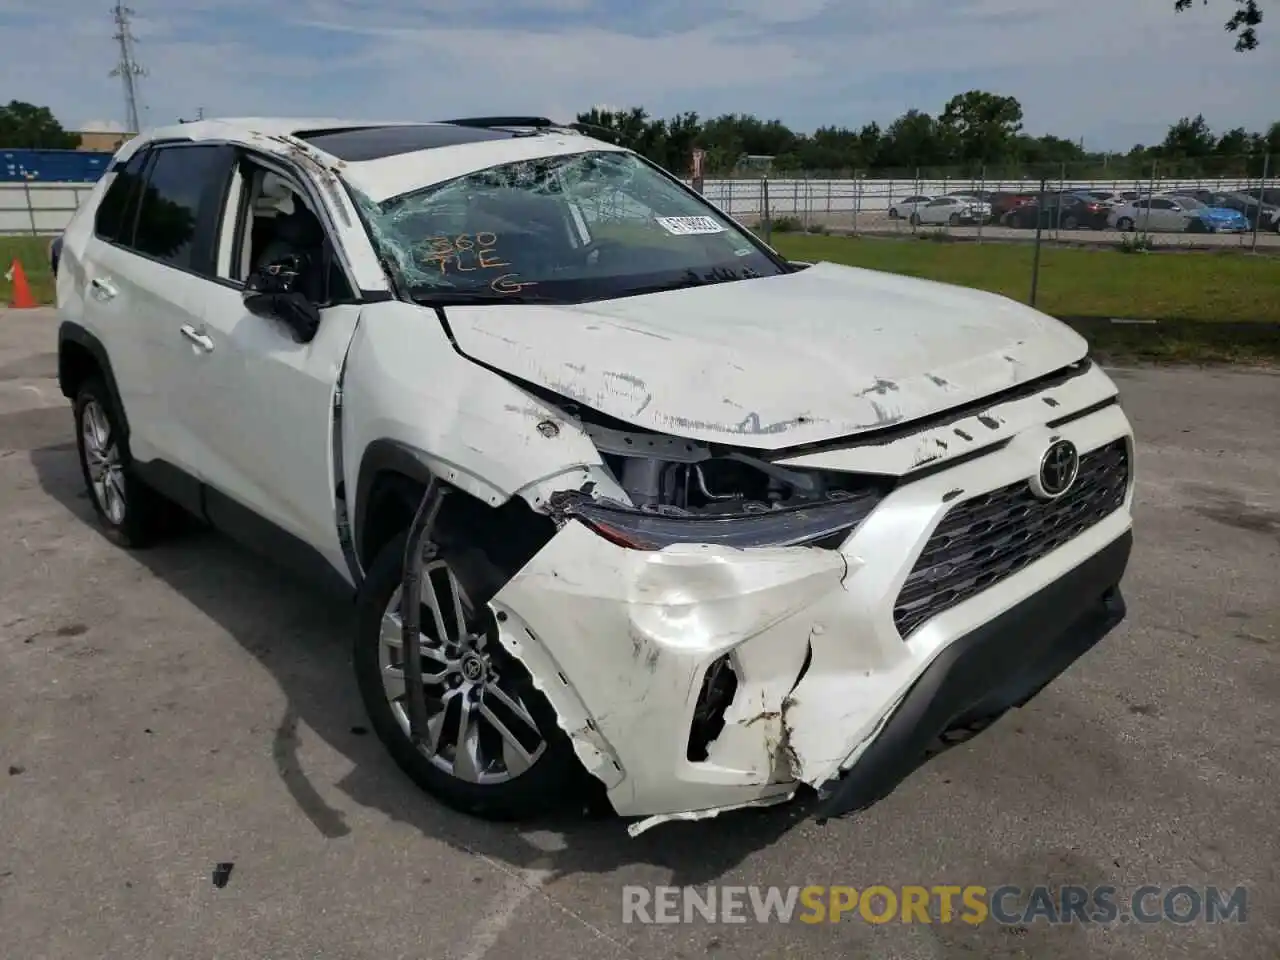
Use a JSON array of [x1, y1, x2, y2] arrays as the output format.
[[447, 262, 1087, 449]]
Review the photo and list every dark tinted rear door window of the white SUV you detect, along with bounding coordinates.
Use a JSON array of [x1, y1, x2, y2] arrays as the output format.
[[133, 143, 230, 270]]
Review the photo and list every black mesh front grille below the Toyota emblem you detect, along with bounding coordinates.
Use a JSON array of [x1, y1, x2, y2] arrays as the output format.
[[893, 439, 1129, 640]]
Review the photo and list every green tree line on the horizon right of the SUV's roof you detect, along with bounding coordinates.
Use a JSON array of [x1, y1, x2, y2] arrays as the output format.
[[577, 96, 1280, 179]]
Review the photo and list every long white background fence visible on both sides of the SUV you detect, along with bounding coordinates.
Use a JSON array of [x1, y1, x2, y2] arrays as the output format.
[[0, 179, 1274, 236]]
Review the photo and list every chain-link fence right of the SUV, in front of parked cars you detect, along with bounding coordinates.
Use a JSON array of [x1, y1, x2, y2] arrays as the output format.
[[701, 156, 1280, 250]]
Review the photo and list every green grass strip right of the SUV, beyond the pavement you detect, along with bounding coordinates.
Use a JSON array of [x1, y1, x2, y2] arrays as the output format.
[[773, 234, 1280, 323]]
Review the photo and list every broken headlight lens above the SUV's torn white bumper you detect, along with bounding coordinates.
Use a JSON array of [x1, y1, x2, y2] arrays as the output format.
[[563, 493, 881, 550]]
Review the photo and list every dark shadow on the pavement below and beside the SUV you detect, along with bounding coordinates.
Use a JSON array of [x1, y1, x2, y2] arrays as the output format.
[[31, 436, 809, 886]]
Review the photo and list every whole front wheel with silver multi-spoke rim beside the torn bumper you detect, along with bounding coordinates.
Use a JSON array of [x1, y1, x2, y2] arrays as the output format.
[[355, 534, 588, 820]]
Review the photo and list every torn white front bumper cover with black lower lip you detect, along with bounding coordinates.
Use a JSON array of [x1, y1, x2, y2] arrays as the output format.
[[483, 407, 1133, 832]]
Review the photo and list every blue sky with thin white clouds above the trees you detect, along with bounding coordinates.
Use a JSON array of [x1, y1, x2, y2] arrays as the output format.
[[0, 0, 1280, 148]]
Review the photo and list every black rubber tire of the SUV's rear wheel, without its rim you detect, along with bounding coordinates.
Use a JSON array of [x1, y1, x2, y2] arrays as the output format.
[[73, 376, 178, 549]]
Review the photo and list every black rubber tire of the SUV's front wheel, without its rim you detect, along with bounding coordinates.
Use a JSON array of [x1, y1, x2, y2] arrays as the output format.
[[353, 531, 593, 820]]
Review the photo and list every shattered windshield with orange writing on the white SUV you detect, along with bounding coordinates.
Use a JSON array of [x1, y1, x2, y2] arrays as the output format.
[[355, 151, 786, 303]]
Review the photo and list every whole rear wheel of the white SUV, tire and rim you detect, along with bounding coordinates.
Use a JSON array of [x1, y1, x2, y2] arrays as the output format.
[[74, 376, 177, 548]]
